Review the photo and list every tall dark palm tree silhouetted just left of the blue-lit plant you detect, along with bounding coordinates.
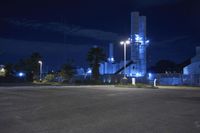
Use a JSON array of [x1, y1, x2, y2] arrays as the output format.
[[87, 47, 106, 80]]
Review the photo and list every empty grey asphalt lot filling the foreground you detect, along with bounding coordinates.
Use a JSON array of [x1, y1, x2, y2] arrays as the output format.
[[0, 86, 200, 133]]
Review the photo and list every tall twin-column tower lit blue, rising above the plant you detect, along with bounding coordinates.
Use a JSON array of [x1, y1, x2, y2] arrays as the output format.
[[130, 12, 148, 77]]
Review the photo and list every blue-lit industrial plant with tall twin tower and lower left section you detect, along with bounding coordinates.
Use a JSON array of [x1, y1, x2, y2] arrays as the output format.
[[100, 12, 149, 77]]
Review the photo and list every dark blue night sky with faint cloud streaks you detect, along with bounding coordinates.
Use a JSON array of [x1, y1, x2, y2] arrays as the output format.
[[0, 0, 200, 69]]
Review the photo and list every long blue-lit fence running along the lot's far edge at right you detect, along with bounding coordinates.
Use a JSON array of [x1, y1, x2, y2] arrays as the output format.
[[101, 73, 200, 86]]
